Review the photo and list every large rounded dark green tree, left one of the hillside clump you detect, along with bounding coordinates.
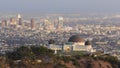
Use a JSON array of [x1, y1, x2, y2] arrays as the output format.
[[6, 46, 35, 60]]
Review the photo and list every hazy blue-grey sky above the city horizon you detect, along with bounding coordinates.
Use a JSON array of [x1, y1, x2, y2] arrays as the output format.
[[0, 0, 120, 13]]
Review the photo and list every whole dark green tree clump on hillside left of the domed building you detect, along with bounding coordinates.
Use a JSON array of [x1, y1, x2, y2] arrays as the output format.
[[6, 46, 54, 60]]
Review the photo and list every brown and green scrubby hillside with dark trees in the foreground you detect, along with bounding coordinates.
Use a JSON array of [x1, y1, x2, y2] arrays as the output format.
[[0, 47, 120, 68]]
